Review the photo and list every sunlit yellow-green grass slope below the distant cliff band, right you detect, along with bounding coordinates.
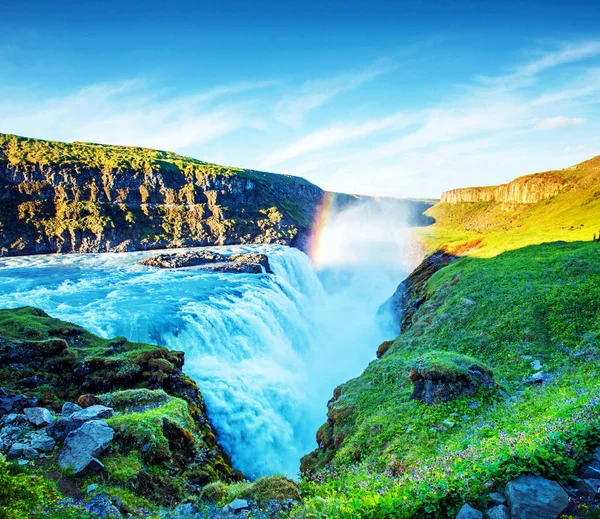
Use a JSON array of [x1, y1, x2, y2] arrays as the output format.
[[419, 157, 600, 257]]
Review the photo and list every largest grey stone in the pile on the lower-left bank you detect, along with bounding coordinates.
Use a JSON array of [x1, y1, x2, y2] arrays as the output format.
[[58, 420, 115, 474]]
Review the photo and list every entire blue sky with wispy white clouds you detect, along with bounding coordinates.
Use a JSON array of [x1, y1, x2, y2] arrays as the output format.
[[0, 0, 600, 197]]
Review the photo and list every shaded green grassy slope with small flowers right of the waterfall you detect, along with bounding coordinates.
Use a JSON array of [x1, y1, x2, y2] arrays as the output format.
[[300, 242, 600, 518]]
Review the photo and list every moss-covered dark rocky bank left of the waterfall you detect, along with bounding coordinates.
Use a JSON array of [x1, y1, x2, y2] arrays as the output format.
[[0, 307, 241, 505]]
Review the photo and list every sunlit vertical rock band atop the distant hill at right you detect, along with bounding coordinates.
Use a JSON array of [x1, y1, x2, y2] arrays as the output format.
[[441, 173, 567, 204]]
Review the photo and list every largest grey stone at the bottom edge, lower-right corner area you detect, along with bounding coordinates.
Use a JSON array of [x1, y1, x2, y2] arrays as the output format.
[[506, 474, 569, 519]]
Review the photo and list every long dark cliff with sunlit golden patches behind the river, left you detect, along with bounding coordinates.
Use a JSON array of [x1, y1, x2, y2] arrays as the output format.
[[0, 134, 431, 255]]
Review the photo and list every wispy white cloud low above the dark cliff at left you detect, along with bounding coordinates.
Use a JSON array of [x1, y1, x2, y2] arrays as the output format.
[[0, 80, 271, 150]]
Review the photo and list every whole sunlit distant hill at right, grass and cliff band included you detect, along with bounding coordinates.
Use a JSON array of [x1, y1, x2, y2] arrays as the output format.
[[420, 156, 600, 257]]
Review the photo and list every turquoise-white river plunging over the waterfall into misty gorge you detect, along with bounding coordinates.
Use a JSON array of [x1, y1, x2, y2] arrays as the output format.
[[0, 201, 414, 477]]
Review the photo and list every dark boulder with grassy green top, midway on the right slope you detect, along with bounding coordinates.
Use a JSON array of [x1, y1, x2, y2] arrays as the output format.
[[409, 352, 496, 405]]
